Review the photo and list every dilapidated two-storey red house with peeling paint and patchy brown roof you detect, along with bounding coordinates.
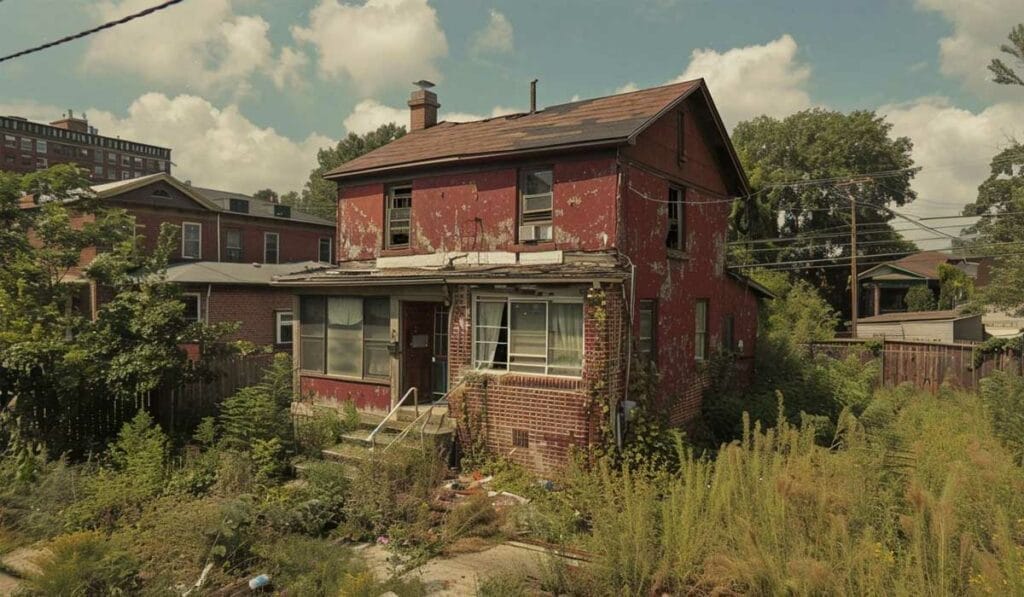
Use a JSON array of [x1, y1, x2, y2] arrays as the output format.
[[274, 80, 764, 472]]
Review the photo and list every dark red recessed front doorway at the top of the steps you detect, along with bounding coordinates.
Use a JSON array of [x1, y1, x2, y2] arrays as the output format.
[[399, 301, 441, 403]]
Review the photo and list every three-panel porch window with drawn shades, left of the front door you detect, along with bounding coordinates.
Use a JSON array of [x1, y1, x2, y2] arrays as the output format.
[[299, 296, 391, 380]]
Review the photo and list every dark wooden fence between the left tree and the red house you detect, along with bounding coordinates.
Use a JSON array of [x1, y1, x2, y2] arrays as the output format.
[[146, 354, 274, 434]]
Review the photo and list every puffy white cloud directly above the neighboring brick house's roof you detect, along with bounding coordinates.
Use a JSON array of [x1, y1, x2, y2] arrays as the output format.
[[88, 93, 334, 193]]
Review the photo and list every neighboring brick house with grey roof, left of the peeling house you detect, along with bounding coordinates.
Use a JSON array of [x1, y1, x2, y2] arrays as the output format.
[[25, 173, 335, 350]]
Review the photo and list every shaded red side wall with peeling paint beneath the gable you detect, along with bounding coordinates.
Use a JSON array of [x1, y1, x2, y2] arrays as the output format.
[[623, 103, 758, 422]]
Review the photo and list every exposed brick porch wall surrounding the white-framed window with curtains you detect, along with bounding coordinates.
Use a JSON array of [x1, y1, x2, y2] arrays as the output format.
[[449, 286, 626, 474]]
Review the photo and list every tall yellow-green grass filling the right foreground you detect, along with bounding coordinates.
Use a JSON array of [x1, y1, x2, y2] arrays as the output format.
[[561, 388, 1024, 595]]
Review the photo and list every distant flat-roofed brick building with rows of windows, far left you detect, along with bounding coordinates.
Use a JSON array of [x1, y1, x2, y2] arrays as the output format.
[[0, 111, 171, 183]]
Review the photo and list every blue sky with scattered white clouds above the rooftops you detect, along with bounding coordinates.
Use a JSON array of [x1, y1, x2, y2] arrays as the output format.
[[0, 0, 1024, 233]]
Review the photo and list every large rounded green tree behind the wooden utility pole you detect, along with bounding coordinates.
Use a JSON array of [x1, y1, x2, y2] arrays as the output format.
[[732, 109, 916, 321]]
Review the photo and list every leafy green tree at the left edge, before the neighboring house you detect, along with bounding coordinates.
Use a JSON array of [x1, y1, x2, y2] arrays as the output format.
[[0, 166, 205, 454]]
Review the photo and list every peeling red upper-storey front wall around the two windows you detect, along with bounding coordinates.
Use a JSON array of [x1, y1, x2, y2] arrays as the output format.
[[338, 156, 616, 261]]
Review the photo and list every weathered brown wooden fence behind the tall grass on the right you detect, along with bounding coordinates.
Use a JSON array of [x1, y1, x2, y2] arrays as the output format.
[[811, 340, 1024, 392]]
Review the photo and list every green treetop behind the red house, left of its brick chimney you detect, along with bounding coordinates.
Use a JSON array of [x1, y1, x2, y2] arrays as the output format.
[[281, 122, 406, 221]]
